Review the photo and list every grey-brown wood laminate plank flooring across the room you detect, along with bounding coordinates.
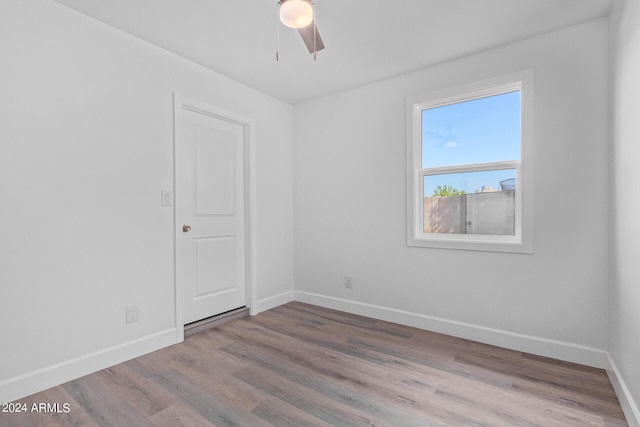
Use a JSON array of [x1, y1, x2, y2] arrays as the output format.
[[0, 302, 627, 427]]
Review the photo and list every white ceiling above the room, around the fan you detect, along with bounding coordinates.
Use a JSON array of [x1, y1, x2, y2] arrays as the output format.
[[56, 0, 611, 104]]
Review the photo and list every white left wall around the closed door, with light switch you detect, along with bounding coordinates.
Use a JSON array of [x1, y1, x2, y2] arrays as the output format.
[[0, 0, 293, 401]]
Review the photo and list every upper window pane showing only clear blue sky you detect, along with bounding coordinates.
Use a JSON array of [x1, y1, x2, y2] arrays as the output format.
[[421, 91, 520, 168]]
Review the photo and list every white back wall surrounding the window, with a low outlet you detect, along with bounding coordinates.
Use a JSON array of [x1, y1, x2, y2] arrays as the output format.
[[294, 19, 609, 366]]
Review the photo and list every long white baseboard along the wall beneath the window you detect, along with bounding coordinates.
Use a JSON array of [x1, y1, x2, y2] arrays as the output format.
[[294, 291, 609, 369]]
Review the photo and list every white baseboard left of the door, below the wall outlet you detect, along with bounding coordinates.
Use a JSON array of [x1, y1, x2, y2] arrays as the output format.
[[0, 328, 176, 403]]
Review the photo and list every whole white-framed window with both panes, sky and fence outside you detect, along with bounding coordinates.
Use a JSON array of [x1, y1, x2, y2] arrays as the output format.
[[407, 71, 533, 253]]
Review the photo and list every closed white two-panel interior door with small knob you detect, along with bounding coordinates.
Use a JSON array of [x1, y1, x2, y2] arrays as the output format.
[[176, 102, 247, 324]]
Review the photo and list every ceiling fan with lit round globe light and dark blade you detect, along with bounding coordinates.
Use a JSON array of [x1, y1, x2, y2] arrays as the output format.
[[276, 0, 324, 61]]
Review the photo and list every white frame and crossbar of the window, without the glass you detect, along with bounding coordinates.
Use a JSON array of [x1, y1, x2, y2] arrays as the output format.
[[407, 70, 534, 253]]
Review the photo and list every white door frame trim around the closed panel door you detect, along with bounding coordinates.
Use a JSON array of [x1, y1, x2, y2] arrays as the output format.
[[173, 92, 258, 342]]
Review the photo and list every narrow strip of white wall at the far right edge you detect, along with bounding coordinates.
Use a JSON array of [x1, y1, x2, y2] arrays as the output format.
[[609, 0, 640, 425]]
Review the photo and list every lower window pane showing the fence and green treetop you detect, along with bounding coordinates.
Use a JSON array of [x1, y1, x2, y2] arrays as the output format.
[[423, 169, 516, 236]]
